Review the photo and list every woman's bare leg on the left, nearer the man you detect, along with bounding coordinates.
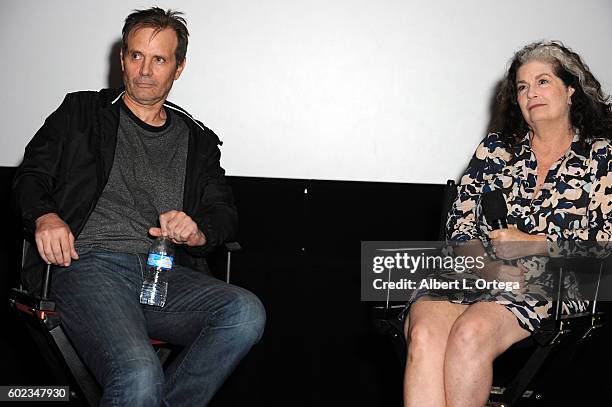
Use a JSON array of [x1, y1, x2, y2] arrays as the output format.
[[404, 300, 468, 407]]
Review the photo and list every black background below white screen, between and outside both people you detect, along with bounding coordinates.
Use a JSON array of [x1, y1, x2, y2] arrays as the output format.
[[0, 167, 612, 407]]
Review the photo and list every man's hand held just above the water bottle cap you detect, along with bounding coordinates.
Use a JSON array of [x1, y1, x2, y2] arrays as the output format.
[[149, 210, 206, 246]]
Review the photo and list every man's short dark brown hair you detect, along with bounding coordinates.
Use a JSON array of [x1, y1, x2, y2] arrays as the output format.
[[121, 7, 189, 67]]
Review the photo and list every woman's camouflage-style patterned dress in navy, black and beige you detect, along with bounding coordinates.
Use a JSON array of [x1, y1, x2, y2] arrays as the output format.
[[442, 133, 612, 332]]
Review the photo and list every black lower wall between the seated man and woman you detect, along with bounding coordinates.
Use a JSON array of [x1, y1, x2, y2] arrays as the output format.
[[215, 177, 443, 406]]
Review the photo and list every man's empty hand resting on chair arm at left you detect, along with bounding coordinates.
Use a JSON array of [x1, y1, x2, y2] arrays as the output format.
[[34, 213, 79, 267]]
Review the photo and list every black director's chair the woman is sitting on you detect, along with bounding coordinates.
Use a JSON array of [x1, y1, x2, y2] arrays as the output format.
[[372, 180, 609, 407]]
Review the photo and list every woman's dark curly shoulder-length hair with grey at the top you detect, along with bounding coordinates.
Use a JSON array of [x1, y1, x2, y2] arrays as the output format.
[[491, 41, 612, 146]]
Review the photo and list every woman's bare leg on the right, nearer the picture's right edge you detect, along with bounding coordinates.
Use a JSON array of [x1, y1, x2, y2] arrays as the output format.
[[444, 302, 530, 407]]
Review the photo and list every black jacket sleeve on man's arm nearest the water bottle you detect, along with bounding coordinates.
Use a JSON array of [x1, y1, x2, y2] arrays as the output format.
[[185, 139, 238, 257]]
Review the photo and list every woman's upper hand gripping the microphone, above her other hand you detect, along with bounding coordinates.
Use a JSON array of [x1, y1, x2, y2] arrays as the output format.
[[489, 226, 548, 260]]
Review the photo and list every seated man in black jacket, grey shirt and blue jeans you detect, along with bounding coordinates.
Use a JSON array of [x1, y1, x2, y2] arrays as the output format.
[[14, 7, 265, 407]]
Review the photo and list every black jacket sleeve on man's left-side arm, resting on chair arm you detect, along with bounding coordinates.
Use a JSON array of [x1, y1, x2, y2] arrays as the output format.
[[13, 95, 70, 237]]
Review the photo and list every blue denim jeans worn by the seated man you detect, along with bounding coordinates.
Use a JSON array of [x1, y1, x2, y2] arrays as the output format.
[[52, 251, 265, 407]]
